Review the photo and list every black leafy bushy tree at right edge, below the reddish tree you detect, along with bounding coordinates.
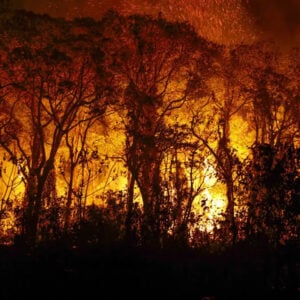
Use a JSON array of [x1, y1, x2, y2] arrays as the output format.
[[244, 144, 299, 247]]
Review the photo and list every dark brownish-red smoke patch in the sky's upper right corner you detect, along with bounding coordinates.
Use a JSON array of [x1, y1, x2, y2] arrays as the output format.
[[245, 0, 300, 47]]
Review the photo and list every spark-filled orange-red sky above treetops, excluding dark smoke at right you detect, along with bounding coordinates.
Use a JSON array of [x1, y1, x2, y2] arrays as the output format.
[[19, 0, 256, 44]]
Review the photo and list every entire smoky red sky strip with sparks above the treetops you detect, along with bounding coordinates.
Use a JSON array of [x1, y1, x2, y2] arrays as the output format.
[[12, 0, 300, 45]]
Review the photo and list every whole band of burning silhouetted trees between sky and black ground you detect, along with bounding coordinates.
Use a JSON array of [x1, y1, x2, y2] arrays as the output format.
[[0, 5, 300, 246]]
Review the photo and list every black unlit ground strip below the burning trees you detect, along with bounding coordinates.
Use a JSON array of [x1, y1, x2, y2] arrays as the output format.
[[0, 245, 300, 300]]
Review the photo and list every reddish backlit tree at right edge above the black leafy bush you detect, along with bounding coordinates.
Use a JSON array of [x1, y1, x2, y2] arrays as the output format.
[[232, 42, 299, 145]]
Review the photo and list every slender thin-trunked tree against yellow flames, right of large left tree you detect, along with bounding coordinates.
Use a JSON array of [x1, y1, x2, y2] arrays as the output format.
[[58, 116, 109, 233]]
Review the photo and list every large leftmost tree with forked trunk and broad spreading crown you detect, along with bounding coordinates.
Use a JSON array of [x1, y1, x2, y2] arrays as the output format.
[[0, 18, 108, 244]]
